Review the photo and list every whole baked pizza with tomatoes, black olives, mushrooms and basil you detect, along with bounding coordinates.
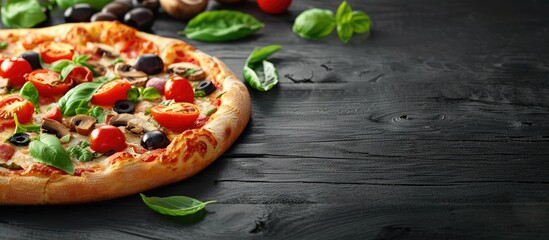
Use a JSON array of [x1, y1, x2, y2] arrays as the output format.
[[0, 22, 251, 204]]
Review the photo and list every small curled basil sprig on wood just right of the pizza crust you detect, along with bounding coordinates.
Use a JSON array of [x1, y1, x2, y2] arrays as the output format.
[[243, 45, 282, 91]]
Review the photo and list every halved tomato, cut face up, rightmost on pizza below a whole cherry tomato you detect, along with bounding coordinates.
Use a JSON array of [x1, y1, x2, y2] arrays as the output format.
[[151, 102, 200, 132]]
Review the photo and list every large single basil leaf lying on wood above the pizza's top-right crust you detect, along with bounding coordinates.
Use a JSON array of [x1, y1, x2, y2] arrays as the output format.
[[179, 10, 264, 42]]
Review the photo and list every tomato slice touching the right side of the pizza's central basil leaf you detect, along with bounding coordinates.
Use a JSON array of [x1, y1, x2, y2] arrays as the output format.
[[91, 79, 132, 106]]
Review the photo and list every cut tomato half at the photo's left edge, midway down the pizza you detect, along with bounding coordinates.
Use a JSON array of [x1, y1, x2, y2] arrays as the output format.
[[0, 95, 34, 127]]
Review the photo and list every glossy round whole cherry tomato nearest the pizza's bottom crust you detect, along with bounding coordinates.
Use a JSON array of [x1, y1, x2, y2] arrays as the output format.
[[90, 125, 128, 153]]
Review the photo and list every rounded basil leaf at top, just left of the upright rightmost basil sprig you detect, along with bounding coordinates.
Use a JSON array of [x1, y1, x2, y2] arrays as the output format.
[[292, 8, 336, 39]]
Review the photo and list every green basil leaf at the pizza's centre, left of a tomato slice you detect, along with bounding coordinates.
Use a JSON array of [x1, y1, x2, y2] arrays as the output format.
[[57, 82, 103, 116]]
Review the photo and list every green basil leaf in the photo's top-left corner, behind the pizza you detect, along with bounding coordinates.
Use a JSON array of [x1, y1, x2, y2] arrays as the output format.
[[0, 0, 47, 28]]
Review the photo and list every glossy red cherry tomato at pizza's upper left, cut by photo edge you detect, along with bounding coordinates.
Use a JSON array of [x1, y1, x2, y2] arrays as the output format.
[[0, 57, 32, 88]]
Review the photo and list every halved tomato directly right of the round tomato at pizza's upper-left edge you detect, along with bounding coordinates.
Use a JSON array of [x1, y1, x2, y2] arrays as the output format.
[[25, 69, 73, 96]]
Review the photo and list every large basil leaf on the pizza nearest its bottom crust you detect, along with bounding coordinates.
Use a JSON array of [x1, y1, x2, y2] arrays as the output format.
[[29, 134, 74, 175]]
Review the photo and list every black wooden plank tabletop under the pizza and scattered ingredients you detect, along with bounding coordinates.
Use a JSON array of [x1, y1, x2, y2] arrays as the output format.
[[0, 0, 549, 239]]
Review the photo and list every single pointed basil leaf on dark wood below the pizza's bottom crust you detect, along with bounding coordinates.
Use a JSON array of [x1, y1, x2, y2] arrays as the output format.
[[140, 194, 216, 216]]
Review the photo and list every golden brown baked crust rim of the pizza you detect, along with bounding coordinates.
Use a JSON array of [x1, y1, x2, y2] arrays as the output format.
[[0, 22, 251, 204]]
